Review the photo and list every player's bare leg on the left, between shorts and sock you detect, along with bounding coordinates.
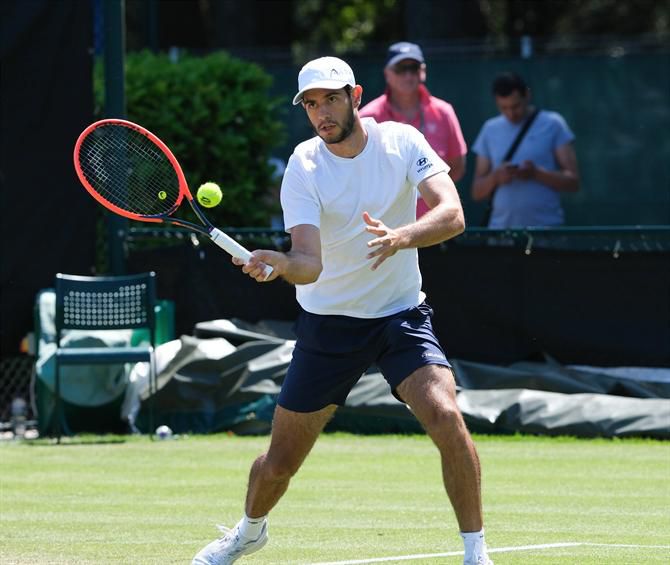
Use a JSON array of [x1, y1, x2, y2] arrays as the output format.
[[246, 405, 337, 518]]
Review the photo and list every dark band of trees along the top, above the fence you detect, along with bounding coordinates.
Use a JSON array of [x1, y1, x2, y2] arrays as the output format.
[[126, 0, 670, 61]]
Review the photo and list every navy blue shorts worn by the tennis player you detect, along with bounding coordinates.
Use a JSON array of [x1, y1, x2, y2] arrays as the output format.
[[278, 302, 451, 412]]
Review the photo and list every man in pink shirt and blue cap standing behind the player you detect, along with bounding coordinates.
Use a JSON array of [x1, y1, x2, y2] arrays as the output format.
[[360, 41, 467, 217]]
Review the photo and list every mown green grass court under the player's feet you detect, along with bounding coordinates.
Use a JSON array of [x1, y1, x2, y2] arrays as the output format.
[[0, 434, 670, 565]]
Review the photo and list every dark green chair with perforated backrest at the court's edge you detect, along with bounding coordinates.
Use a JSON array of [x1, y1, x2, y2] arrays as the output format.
[[54, 272, 156, 443]]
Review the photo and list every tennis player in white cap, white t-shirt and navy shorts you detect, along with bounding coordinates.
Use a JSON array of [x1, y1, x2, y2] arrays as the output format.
[[193, 57, 492, 565]]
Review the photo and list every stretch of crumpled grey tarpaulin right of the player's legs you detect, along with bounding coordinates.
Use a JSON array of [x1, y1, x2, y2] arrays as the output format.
[[454, 357, 670, 438]]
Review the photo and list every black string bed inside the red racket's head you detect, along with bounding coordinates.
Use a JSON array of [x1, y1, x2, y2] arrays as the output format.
[[79, 124, 179, 216]]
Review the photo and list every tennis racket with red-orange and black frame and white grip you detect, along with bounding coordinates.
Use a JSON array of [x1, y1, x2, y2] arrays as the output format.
[[74, 119, 272, 279]]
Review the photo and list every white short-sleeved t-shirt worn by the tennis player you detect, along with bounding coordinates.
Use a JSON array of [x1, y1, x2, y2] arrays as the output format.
[[281, 118, 449, 318]]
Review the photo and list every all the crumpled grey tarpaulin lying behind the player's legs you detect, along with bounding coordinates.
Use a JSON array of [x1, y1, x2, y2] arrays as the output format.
[[143, 320, 670, 438]]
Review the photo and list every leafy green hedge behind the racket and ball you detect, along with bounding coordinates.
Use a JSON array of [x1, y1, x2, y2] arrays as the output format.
[[94, 51, 287, 227]]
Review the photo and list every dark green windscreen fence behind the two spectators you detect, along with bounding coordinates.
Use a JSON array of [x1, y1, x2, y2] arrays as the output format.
[[264, 51, 670, 226]]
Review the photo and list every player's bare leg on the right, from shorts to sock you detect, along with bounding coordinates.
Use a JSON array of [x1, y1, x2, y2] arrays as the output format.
[[397, 365, 483, 532]]
